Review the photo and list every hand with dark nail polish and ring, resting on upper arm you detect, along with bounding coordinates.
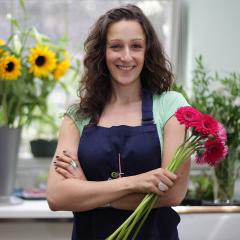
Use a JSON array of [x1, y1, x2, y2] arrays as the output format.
[[54, 151, 86, 180]]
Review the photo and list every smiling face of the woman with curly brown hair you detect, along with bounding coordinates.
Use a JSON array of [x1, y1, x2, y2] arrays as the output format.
[[106, 20, 146, 86]]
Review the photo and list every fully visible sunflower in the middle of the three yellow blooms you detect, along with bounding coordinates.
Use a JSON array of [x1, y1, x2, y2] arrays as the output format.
[[28, 45, 56, 77]]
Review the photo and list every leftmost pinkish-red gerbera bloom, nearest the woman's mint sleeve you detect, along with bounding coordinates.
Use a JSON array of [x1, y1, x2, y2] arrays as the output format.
[[175, 106, 202, 128]]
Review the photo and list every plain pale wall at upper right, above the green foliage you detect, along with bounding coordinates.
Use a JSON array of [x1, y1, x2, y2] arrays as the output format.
[[178, 0, 240, 89]]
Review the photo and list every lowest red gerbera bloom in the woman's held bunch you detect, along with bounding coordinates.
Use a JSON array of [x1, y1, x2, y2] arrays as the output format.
[[204, 139, 228, 166]]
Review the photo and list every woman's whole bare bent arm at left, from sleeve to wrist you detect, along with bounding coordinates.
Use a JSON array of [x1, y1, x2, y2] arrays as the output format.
[[47, 116, 131, 211]]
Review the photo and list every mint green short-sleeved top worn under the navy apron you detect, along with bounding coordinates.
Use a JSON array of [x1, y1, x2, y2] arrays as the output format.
[[66, 91, 189, 156]]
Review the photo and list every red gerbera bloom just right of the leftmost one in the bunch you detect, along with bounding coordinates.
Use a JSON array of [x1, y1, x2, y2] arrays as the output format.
[[196, 114, 218, 137]]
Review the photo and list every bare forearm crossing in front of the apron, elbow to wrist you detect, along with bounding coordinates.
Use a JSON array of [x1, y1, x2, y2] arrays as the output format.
[[47, 178, 132, 211]]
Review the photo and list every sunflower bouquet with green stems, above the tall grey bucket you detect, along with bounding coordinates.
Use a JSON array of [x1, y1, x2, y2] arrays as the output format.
[[0, 15, 77, 128]]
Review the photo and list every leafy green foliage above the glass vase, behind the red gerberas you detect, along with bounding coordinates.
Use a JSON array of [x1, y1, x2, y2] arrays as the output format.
[[191, 56, 240, 159]]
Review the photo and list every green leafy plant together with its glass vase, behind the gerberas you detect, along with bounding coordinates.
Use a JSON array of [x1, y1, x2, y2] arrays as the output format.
[[190, 56, 240, 204]]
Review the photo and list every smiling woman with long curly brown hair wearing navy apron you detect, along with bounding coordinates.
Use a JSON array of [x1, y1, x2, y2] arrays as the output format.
[[48, 5, 190, 240]]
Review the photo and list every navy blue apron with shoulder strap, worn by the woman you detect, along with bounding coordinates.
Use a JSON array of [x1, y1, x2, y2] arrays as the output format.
[[72, 90, 180, 240]]
